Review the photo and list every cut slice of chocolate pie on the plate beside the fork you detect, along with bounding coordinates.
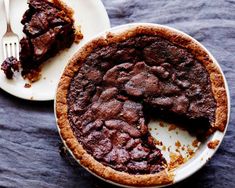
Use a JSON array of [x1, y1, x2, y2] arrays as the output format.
[[1, 0, 83, 81]]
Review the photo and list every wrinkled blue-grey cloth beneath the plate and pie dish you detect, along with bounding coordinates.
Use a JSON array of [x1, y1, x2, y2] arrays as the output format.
[[0, 0, 235, 188]]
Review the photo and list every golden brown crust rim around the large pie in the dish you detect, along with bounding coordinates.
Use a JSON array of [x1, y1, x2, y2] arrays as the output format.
[[56, 26, 227, 187]]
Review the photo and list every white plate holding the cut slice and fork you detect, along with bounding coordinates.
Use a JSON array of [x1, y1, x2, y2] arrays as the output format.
[[0, 0, 110, 101]]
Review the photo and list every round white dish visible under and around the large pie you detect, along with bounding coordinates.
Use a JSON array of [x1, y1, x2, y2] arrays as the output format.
[[55, 23, 230, 187]]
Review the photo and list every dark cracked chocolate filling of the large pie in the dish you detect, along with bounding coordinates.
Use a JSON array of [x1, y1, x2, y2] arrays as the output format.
[[67, 35, 216, 174]]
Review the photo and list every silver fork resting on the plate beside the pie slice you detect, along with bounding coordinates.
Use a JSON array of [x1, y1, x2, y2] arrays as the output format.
[[2, 0, 19, 60]]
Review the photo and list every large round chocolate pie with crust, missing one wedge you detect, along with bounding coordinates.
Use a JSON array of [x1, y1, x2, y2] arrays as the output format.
[[55, 25, 228, 186]]
